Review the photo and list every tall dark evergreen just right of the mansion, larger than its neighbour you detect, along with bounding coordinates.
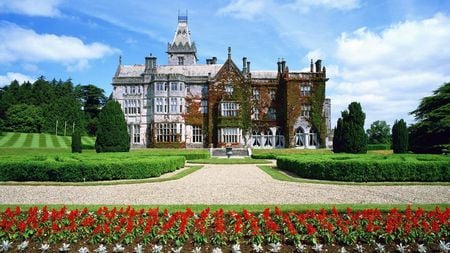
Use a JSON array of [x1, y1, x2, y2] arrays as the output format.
[[333, 102, 367, 154]]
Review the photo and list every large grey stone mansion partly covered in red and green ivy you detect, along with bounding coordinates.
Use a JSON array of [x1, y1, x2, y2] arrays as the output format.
[[112, 16, 331, 148]]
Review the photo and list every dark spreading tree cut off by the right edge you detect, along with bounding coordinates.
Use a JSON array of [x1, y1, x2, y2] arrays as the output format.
[[409, 82, 450, 153]]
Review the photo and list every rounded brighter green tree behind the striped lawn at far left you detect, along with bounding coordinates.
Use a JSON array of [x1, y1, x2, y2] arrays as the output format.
[[5, 104, 44, 133]]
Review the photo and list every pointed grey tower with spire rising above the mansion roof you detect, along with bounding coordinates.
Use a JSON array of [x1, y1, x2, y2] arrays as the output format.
[[167, 11, 197, 65]]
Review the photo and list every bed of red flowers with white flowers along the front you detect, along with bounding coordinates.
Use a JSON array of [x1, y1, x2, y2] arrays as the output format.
[[0, 207, 450, 252]]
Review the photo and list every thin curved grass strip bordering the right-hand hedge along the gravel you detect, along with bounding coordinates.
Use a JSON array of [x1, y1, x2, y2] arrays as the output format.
[[258, 165, 450, 186]]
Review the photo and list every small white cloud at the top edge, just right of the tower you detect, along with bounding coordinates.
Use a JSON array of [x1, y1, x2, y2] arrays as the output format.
[[217, 0, 270, 19]]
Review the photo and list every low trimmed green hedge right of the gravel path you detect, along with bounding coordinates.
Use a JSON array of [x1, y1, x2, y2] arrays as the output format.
[[277, 155, 450, 182]]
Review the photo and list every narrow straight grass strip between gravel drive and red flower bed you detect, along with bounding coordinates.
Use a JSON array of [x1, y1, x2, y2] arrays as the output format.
[[0, 203, 450, 213]]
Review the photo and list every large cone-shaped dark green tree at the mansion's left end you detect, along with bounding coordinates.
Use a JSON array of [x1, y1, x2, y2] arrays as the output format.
[[95, 100, 130, 152]]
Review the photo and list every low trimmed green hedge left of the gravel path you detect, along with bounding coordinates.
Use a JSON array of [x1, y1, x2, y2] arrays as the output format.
[[0, 155, 185, 182]]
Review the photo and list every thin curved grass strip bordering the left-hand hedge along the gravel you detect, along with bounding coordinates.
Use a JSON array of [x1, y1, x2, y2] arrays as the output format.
[[0, 165, 203, 186]]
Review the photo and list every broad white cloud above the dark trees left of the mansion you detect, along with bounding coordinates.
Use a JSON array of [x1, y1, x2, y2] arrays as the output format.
[[0, 22, 119, 70]]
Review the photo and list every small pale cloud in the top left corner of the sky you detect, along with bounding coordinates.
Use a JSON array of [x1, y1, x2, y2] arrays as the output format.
[[0, 0, 61, 17]]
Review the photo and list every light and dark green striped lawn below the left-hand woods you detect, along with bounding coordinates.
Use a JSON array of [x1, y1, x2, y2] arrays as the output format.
[[0, 133, 95, 149]]
